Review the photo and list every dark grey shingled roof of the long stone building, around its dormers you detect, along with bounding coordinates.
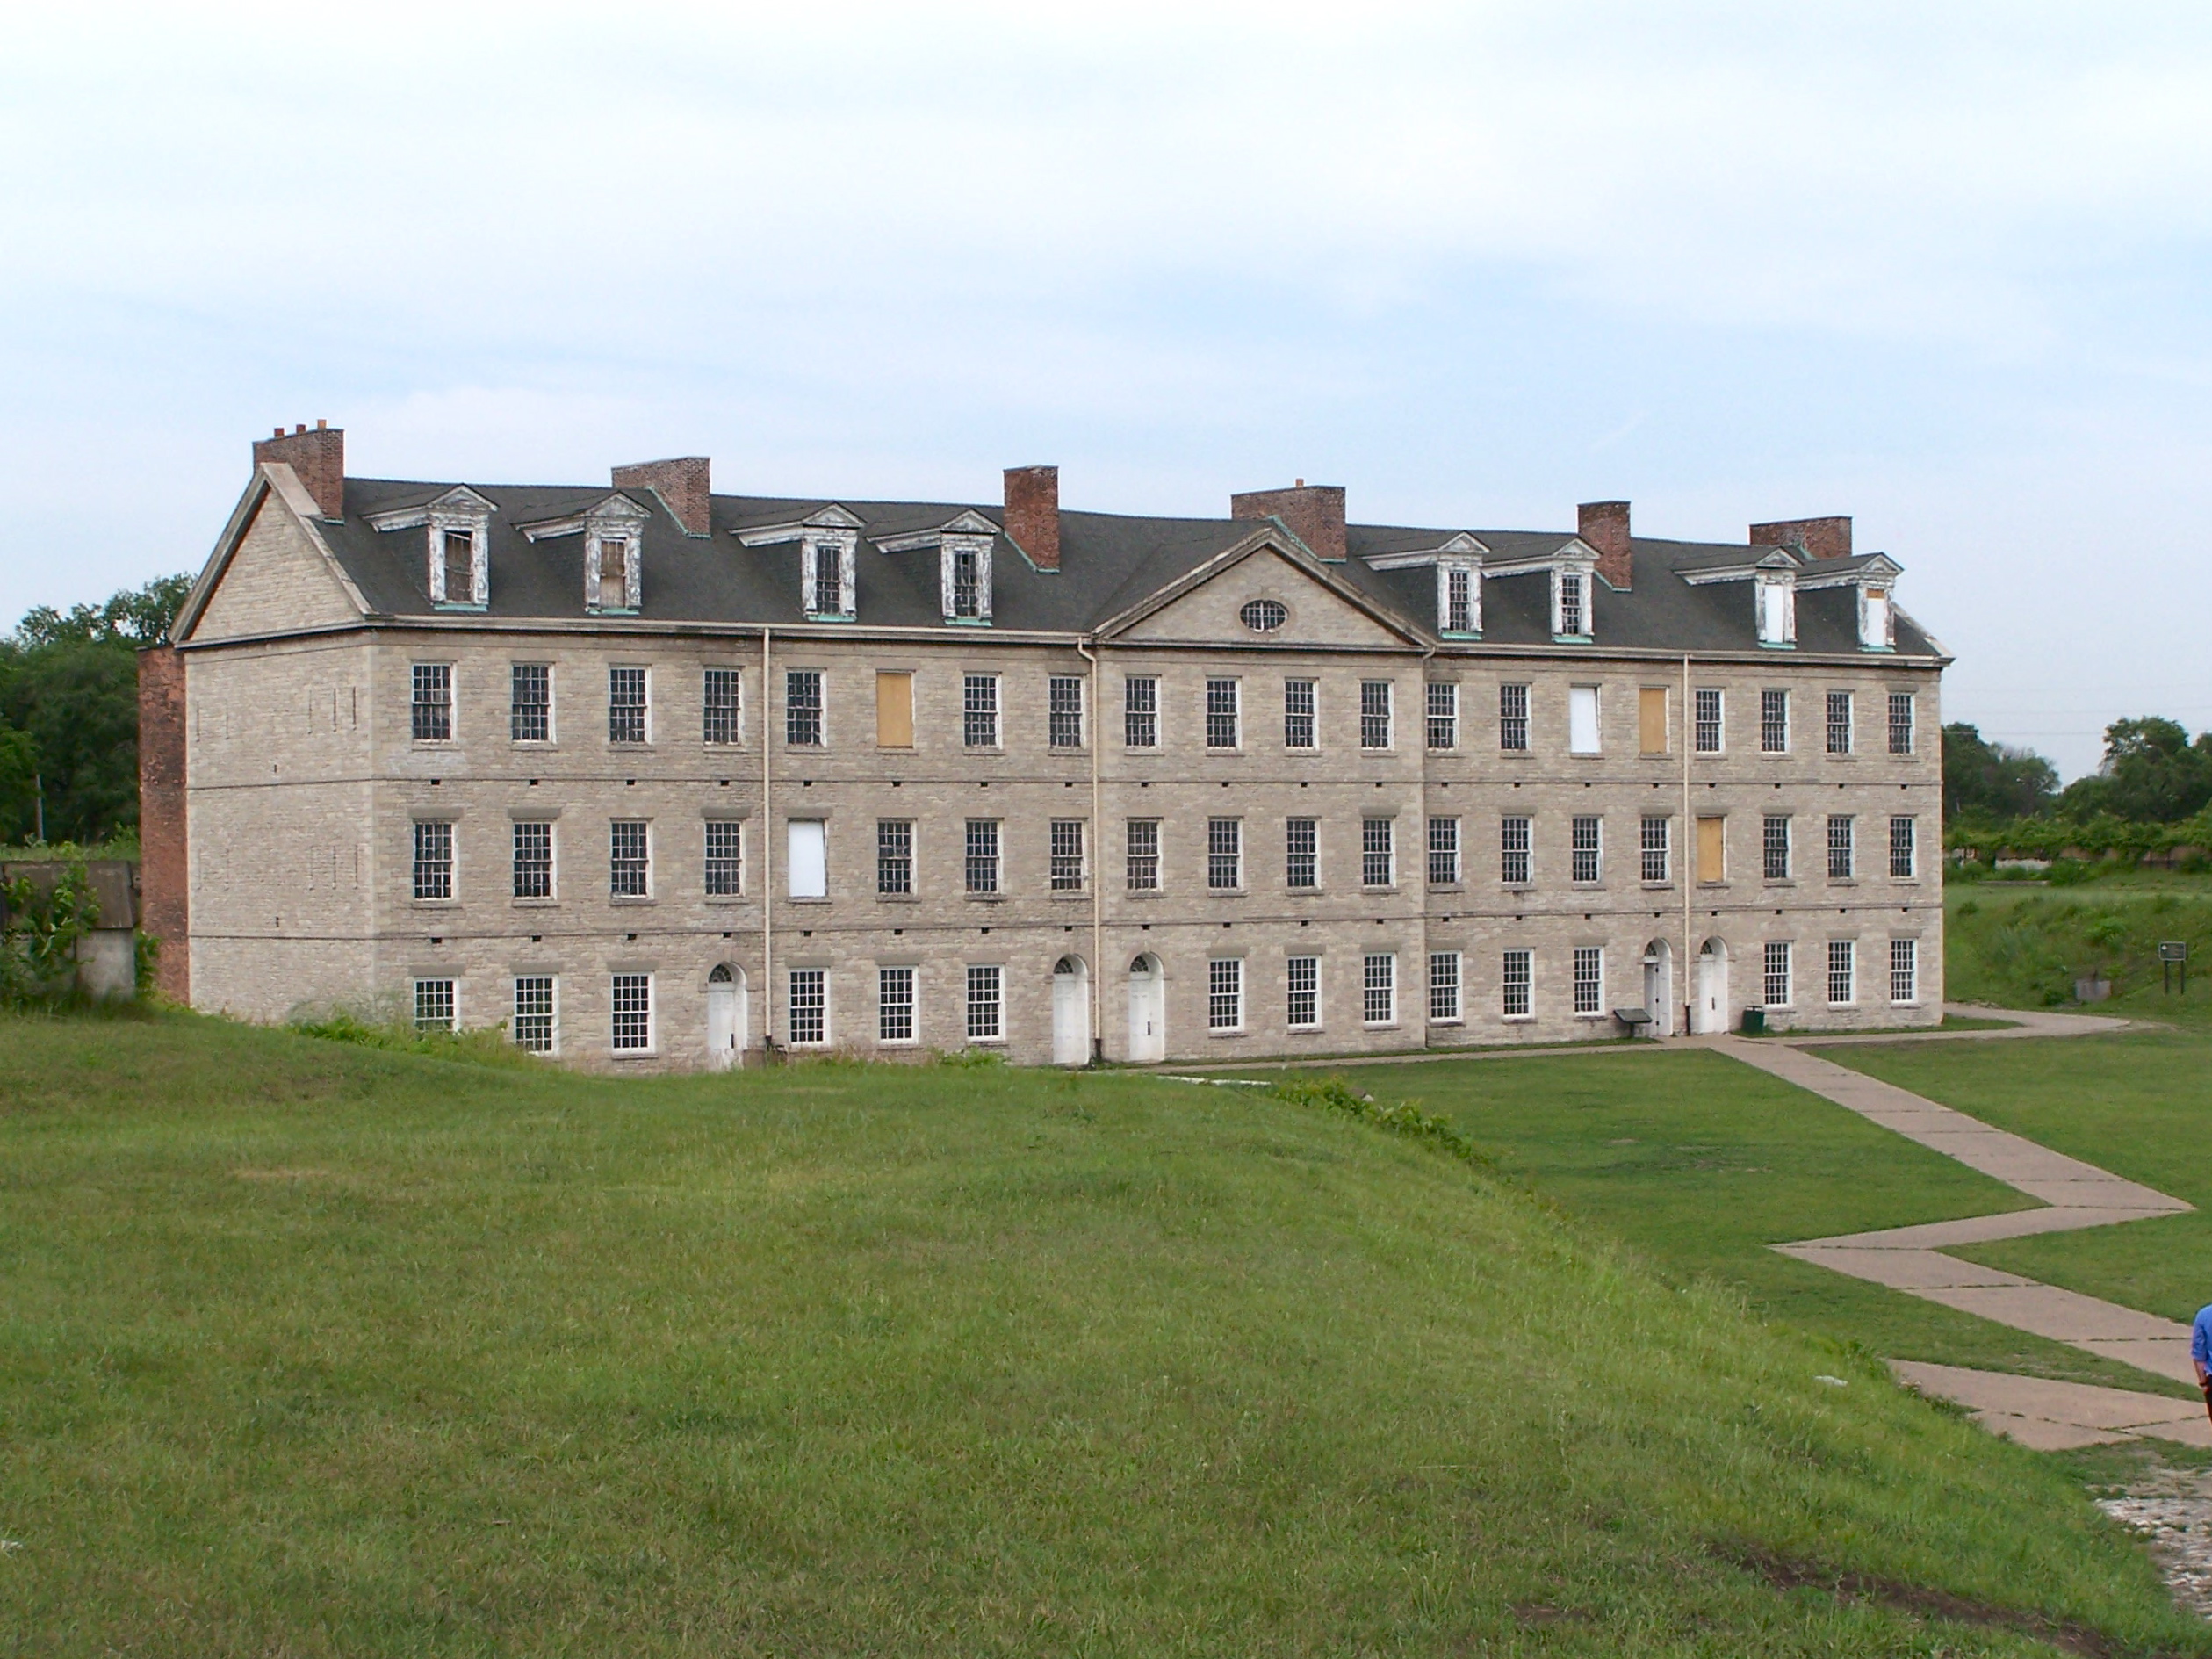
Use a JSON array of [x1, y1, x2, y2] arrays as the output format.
[[319, 478, 1940, 657]]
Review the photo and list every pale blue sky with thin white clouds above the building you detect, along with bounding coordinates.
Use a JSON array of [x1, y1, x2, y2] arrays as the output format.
[[0, 0, 2212, 776]]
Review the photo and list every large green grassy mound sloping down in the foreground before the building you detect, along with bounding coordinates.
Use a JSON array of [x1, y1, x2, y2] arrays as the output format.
[[0, 1015, 2212, 1655]]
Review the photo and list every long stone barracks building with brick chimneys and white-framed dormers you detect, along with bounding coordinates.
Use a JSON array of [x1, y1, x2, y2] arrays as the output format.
[[141, 425, 1947, 1069]]
